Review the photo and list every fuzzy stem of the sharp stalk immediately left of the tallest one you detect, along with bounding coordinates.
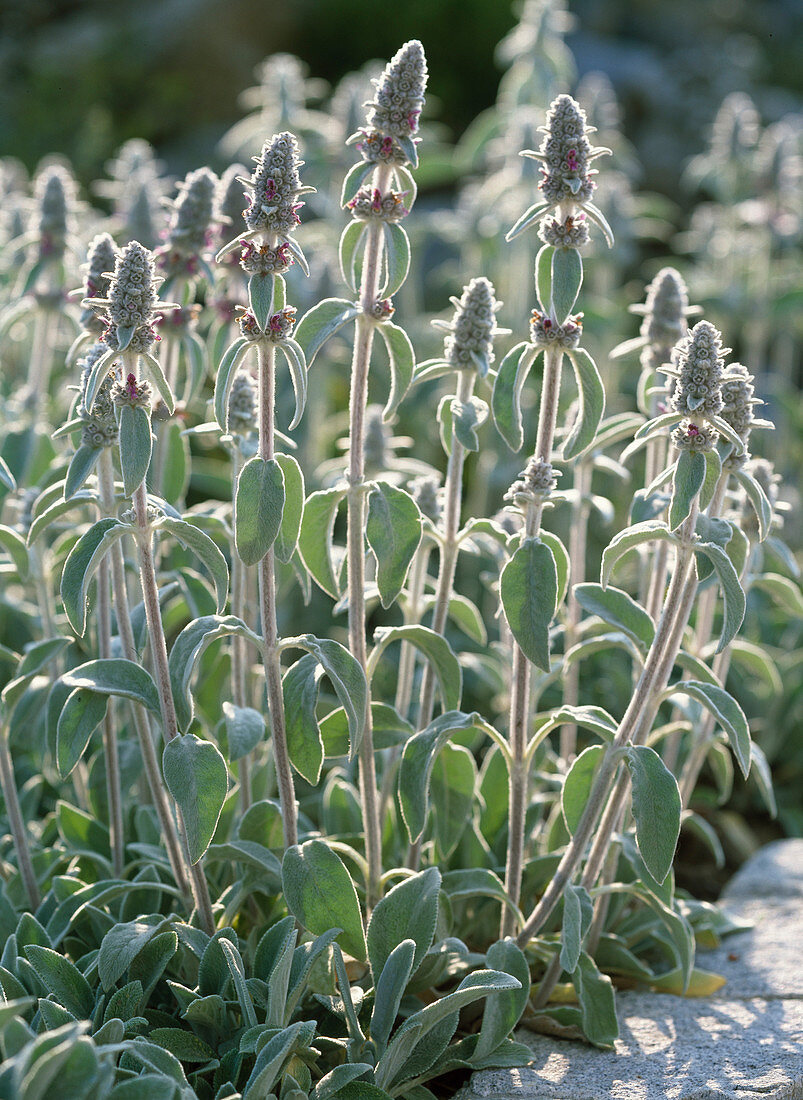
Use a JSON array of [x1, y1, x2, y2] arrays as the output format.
[[256, 340, 298, 848]]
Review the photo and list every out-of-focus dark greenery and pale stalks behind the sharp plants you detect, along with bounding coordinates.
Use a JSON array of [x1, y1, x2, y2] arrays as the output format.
[[0, 0, 803, 895]]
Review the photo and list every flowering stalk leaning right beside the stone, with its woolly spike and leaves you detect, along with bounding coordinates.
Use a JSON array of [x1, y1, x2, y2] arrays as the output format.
[[519, 321, 744, 990]]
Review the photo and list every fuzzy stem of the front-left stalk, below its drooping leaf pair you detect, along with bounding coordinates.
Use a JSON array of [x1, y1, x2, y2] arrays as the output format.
[[132, 482, 215, 936]]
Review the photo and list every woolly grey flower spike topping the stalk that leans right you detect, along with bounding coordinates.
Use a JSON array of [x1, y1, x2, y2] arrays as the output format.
[[661, 321, 730, 451]]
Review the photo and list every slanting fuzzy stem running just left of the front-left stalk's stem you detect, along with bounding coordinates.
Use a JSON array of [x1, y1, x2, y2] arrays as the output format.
[[98, 449, 191, 904]]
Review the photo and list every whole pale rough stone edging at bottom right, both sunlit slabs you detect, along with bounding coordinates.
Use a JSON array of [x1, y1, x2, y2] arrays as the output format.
[[464, 840, 803, 1100]]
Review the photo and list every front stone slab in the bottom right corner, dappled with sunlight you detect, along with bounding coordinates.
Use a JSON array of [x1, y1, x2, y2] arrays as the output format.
[[464, 993, 803, 1100]]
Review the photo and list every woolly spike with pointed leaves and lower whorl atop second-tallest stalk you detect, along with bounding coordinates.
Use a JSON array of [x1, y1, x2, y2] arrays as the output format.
[[506, 96, 614, 249]]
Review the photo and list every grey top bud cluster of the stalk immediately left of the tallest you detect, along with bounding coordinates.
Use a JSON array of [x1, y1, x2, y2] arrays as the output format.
[[244, 131, 304, 238]]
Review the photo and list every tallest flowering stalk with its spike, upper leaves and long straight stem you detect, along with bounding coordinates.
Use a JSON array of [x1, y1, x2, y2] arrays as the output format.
[[299, 40, 427, 908]]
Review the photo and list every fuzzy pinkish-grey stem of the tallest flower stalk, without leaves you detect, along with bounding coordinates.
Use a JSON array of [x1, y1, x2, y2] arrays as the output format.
[[347, 160, 391, 910]]
